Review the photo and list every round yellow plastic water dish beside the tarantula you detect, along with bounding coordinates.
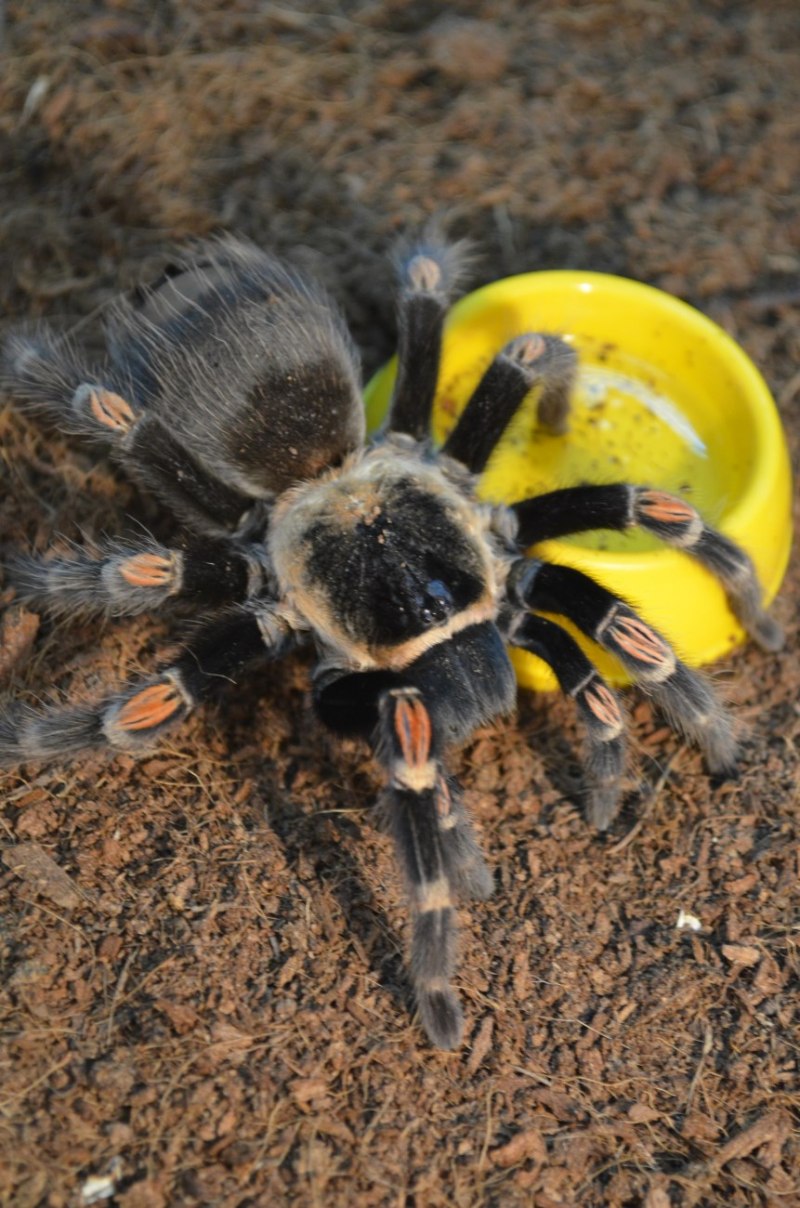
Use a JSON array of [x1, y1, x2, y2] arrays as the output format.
[[365, 272, 792, 691]]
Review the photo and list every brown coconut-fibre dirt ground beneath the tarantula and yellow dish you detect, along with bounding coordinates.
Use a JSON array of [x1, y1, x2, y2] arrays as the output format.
[[0, 0, 800, 1208]]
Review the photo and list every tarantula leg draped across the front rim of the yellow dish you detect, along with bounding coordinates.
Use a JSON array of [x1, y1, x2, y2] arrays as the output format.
[[511, 483, 783, 650]]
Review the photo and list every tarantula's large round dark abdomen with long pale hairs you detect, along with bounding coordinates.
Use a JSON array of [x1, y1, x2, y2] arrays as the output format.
[[109, 238, 364, 499]]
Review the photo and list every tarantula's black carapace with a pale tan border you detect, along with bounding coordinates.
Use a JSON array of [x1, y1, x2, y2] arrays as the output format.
[[275, 445, 498, 669]]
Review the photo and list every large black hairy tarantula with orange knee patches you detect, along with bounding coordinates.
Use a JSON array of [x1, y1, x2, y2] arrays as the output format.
[[0, 237, 781, 1049]]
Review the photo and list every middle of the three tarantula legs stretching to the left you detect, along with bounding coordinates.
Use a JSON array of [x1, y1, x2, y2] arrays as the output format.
[[6, 538, 269, 616]]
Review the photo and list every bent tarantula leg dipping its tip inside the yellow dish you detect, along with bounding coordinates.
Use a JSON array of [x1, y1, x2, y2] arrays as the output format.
[[442, 333, 578, 474]]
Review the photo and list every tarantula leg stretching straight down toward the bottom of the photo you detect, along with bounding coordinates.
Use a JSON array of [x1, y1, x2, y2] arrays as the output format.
[[377, 689, 483, 1049]]
